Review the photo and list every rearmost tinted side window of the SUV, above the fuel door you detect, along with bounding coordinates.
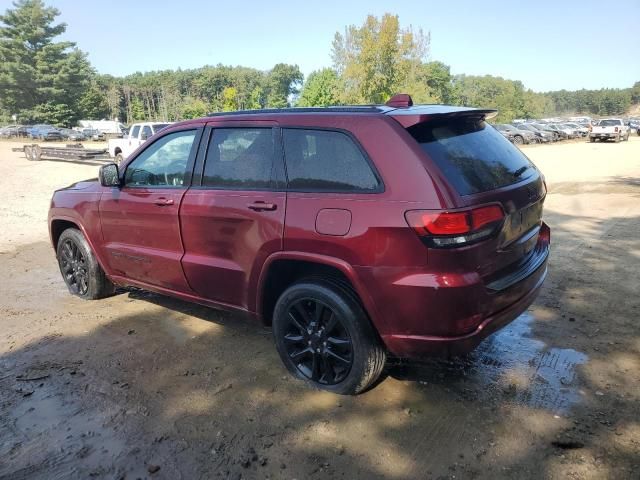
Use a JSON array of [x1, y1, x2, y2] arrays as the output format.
[[283, 129, 380, 191]]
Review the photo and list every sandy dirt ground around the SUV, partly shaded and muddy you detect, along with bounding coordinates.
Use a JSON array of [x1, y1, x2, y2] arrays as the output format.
[[0, 136, 640, 480]]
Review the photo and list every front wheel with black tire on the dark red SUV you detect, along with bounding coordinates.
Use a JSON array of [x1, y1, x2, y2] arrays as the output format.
[[56, 228, 115, 300]]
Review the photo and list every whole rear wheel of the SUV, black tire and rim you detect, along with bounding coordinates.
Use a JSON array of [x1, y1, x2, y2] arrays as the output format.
[[273, 278, 386, 395]]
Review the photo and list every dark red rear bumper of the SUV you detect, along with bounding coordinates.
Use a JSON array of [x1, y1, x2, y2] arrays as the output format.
[[362, 224, 550, 358]]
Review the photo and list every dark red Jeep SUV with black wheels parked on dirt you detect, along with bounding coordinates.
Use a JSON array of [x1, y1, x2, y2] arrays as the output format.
[[49, 95, 550, 394]]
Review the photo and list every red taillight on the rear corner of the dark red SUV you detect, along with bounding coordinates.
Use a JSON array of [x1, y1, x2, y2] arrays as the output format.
[[405, 205, 504, 248]]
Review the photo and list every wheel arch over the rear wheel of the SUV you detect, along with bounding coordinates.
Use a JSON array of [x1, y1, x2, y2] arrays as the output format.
[[251, 252, 381, 331]]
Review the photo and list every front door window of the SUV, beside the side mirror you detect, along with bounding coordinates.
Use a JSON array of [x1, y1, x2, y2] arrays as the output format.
[[125, 130, 196, 187]]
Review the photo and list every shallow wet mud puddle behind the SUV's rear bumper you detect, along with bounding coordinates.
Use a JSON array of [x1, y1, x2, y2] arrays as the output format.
[[390, 312, 588, 414]]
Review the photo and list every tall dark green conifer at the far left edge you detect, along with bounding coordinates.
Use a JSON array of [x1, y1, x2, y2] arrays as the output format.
[[0, 0, 93, 125]]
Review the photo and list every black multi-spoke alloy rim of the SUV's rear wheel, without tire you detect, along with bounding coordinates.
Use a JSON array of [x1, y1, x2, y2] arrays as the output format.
[[284, 298, 353, 385]]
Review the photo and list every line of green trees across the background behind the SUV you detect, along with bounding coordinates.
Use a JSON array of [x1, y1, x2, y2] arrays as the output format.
[[0, 0, 640, 126]]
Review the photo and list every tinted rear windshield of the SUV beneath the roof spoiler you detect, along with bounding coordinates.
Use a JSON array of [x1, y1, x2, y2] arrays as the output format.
[[408, 118, 537, 195]]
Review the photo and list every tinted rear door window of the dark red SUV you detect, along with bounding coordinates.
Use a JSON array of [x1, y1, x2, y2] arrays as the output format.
[[202, 128, 274, 190]]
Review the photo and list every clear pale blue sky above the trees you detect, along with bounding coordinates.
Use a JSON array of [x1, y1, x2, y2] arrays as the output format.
[[0, 0, 640, 91]]
